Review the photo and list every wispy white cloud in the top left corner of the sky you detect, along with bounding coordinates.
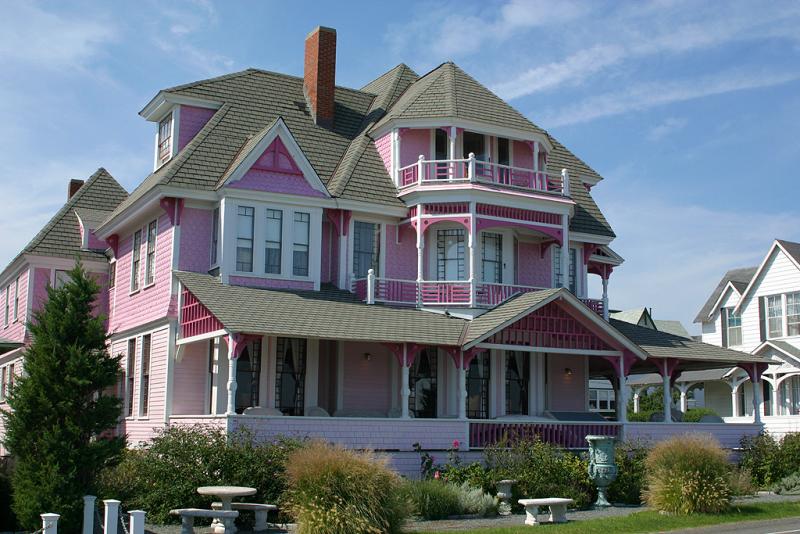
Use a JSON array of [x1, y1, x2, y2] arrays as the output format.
[[0, 2, 114, 69]]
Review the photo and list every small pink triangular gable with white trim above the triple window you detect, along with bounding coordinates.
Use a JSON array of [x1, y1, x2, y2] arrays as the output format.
[[223, 120, 328, 198]]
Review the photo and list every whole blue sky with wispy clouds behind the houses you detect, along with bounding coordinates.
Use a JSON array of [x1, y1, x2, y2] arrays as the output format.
[[0, 0, 800, 331]]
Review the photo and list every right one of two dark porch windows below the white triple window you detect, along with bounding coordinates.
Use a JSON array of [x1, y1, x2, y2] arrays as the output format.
[[275, 337, 306, 415]]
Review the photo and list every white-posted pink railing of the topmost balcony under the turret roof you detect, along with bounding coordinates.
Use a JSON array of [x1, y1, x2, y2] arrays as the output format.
[[398, 154, 569, 197]]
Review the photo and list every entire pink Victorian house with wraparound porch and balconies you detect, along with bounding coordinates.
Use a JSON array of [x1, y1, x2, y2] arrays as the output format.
[[0, 28, 766, 466]]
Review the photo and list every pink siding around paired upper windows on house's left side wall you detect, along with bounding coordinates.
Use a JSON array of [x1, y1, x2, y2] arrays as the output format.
[[110, 214, 175, 333]]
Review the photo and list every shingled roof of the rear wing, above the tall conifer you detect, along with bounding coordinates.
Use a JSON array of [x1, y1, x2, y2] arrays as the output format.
[[1, 167, 128, 278]]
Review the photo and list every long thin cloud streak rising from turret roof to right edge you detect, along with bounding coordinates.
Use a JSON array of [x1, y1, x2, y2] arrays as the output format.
[[541, 70, 800, 128]]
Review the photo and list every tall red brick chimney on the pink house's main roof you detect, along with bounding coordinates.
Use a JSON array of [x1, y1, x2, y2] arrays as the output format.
[[303, 26, 336, 128]]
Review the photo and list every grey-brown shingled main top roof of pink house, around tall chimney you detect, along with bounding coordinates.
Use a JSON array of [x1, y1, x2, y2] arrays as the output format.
[[104, 59, 614, 237]]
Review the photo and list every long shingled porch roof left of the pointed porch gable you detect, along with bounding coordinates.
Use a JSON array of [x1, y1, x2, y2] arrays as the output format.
[[175, 271, 467, 346]]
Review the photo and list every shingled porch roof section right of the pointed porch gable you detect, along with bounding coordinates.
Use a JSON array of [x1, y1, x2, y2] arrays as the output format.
[[610, 319, 772, 369]]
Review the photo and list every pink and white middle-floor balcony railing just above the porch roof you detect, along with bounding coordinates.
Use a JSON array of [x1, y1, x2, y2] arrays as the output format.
[[353, 276, 605, 317]]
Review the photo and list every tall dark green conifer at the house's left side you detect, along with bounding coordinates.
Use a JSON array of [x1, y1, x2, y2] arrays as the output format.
[[2, 263, 125, 532]]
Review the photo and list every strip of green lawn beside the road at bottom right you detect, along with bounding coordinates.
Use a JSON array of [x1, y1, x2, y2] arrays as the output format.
[[416, 502, 800, 534]]
